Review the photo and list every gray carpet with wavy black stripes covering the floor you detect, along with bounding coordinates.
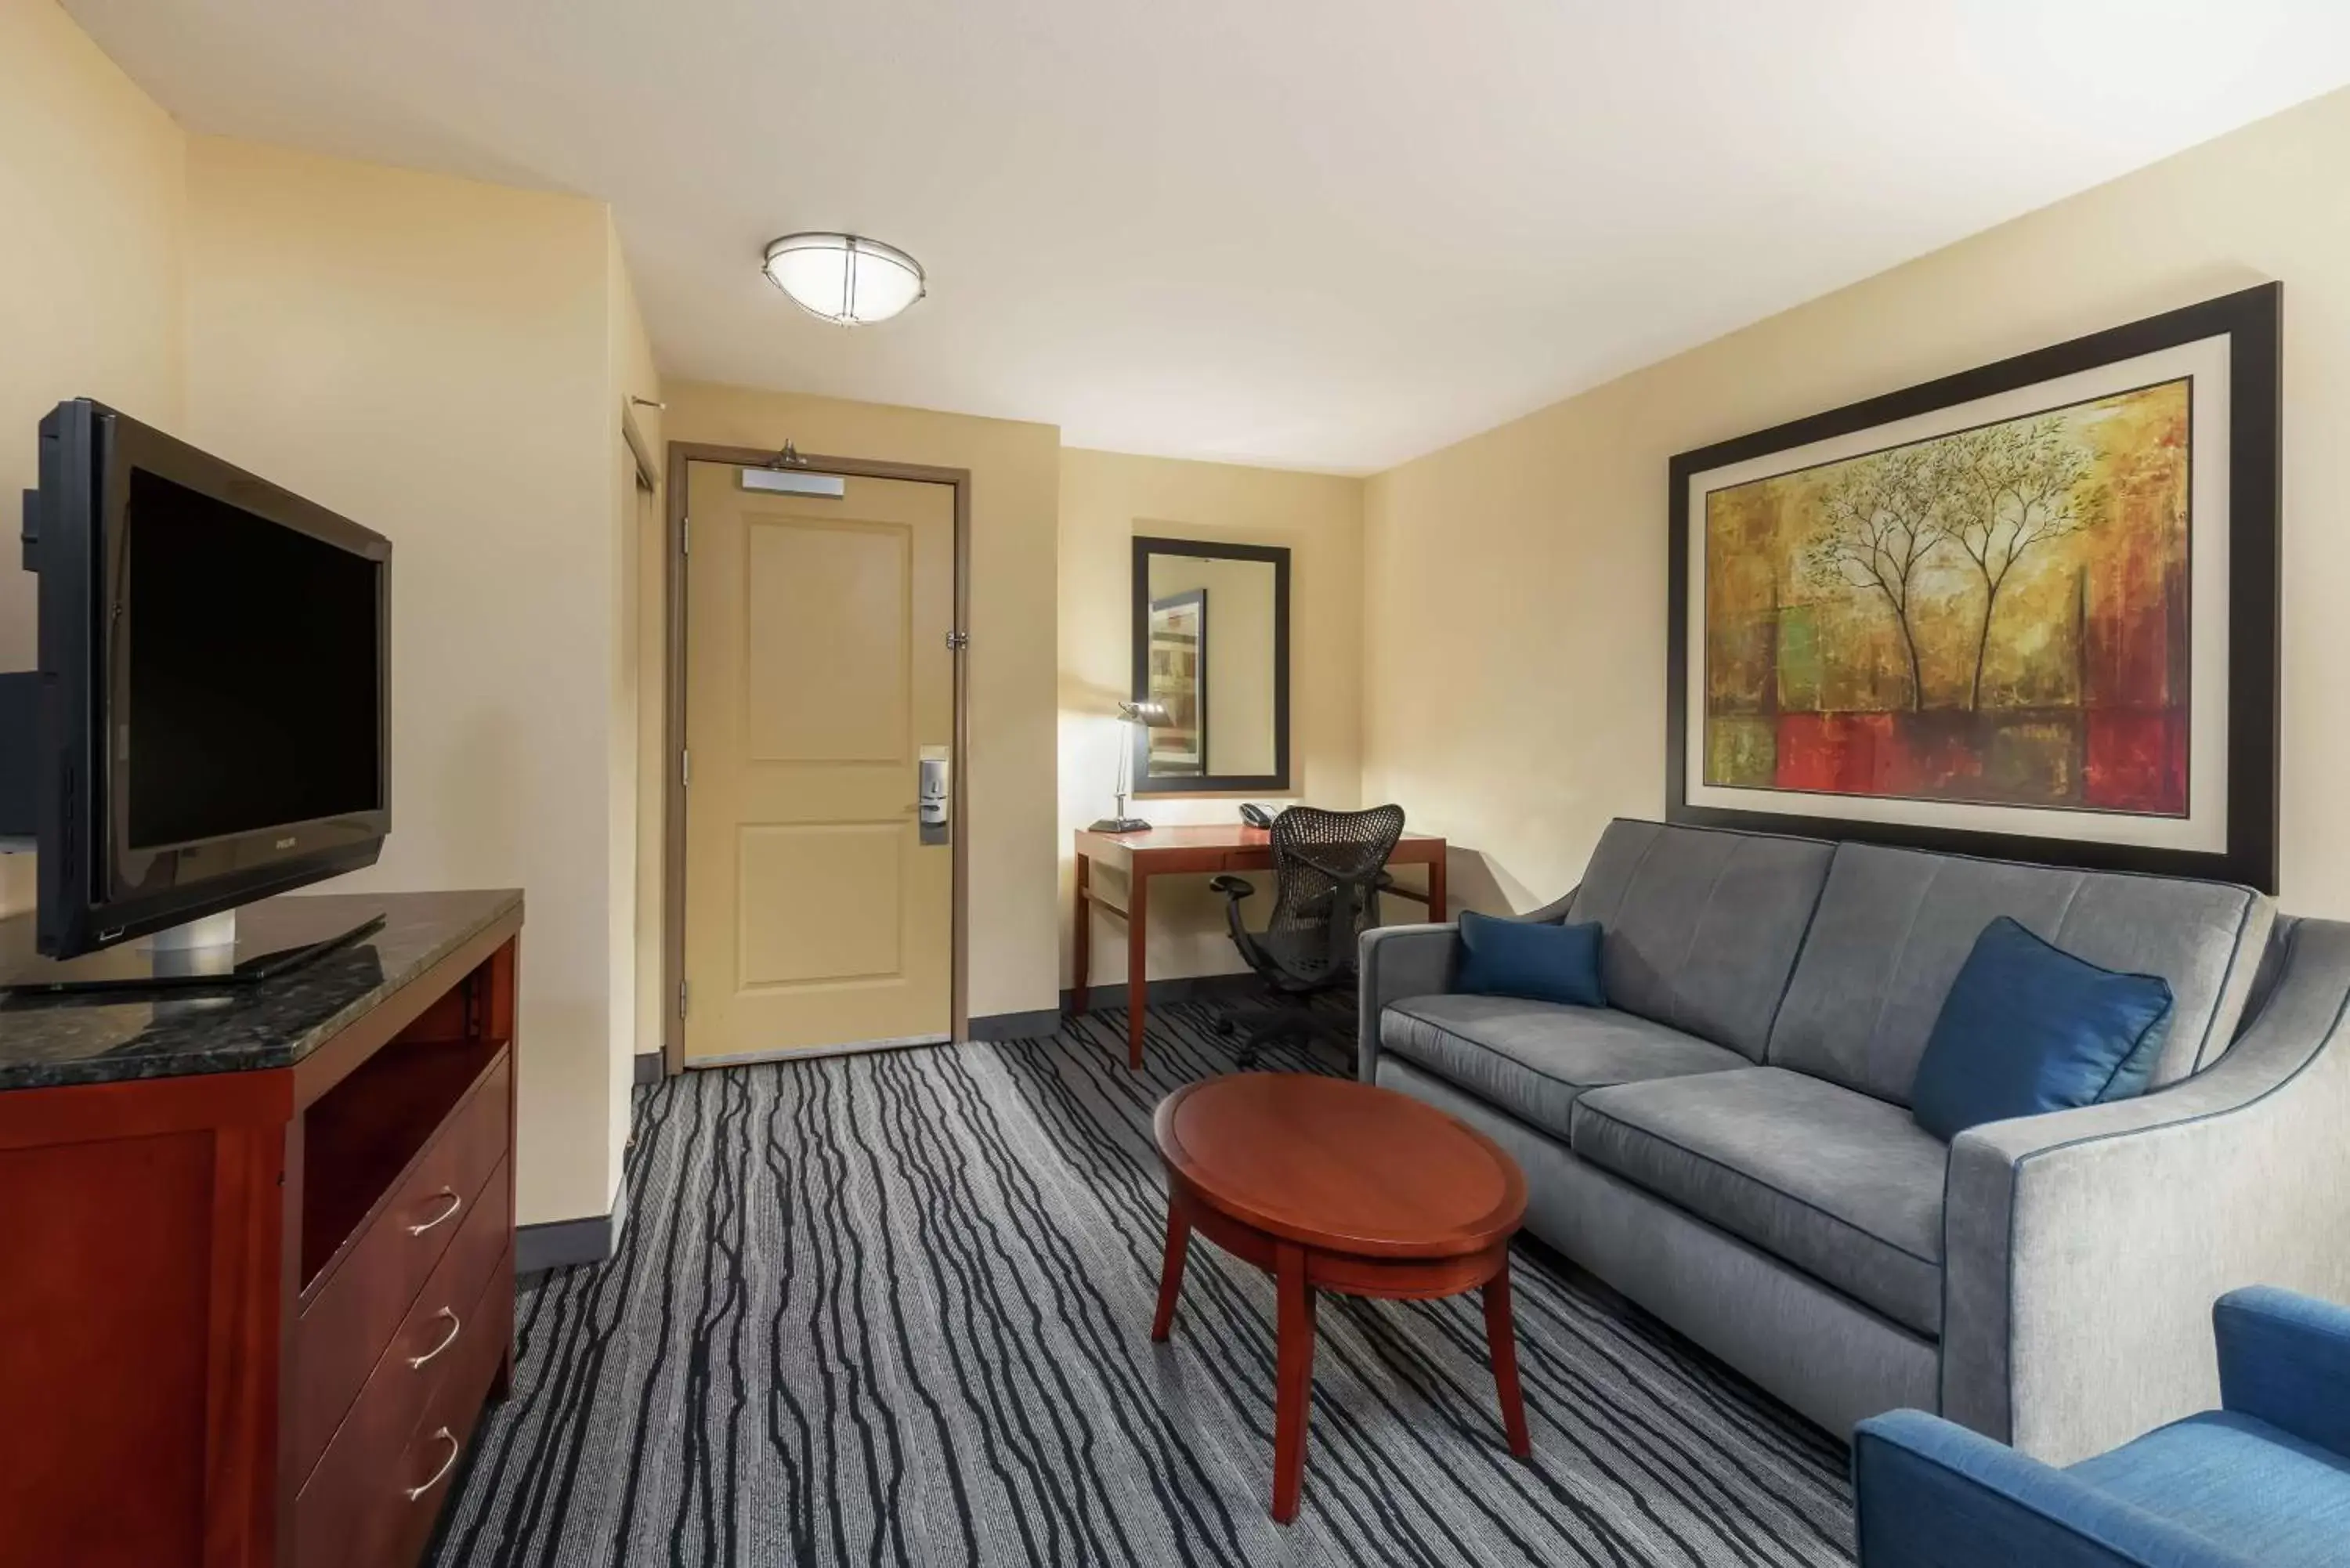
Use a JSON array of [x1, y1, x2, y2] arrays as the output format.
[[435, 1006, 1852, 1568]]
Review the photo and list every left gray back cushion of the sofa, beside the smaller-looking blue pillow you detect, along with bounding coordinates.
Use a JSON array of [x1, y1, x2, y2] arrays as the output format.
[[1567, 818, 1835, 1060]]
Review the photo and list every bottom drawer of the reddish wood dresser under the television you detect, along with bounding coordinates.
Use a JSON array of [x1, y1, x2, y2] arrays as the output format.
[[289, 1246, 515, 1568]]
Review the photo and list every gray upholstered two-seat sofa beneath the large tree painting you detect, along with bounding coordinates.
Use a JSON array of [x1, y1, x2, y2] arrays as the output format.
[[1361, 821, 2350, 1465]]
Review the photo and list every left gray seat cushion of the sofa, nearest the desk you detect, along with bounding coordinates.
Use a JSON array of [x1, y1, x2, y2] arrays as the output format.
[[1379, 995, 1746, 1138]]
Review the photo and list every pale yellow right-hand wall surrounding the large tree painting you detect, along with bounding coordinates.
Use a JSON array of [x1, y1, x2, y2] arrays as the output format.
[[1363, 92, 2350, 917]]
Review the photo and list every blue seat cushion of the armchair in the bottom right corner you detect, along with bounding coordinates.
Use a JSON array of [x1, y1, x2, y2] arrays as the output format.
[[2073, 1411, 2350, 1568]]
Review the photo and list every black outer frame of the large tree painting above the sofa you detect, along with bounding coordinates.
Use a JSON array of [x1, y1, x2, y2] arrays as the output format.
[[1664, 282, 2284, 894]]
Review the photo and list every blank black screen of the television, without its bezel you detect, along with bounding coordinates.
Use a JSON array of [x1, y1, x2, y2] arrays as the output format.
[[113, 468, 383, 849]]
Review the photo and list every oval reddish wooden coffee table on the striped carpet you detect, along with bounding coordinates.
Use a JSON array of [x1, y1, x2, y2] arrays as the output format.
[[1152, 1072, 1532, 1523]]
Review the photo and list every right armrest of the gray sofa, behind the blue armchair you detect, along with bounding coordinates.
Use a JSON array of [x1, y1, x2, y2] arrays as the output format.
[[1941, 919, 2350, 1465]]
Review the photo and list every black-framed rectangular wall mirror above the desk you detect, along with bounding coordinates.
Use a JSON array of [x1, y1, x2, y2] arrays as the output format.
[[1133, 536, 1290, 795]]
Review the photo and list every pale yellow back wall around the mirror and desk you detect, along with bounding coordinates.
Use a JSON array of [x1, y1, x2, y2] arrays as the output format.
[[1058, 446, 1372, 983]]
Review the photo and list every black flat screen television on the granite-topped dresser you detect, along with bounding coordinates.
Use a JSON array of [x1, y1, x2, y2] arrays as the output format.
[[0, 399, 392, 959]]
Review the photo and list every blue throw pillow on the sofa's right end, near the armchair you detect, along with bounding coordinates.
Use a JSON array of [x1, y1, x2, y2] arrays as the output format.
[[1911, 915, 2171, 1143]]
